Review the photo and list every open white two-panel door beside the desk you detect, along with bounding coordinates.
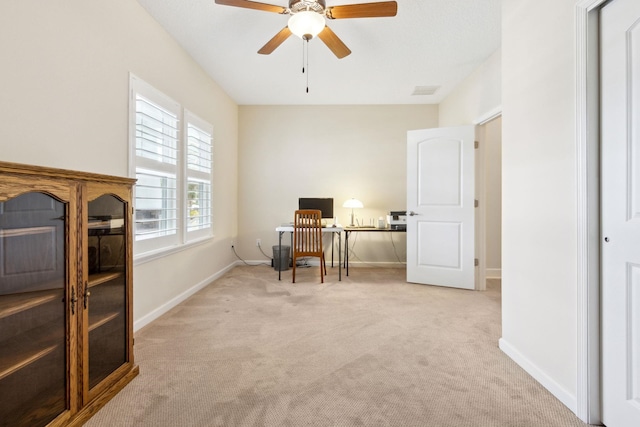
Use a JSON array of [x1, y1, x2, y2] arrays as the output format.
[[407, 126, 475, 289]]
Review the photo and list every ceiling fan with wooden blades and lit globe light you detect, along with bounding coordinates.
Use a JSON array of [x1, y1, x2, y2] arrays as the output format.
[[215, 0, 398, 58]]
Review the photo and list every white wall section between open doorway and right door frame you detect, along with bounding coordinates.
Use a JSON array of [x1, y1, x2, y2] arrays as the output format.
[[500, 0, 578, 412]]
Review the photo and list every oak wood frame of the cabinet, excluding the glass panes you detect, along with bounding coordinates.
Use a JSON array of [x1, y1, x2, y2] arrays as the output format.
[[0, 162, 138, 426]]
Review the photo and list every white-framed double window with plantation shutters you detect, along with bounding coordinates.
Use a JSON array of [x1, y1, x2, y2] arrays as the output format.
[[130, 76, 213, 255]]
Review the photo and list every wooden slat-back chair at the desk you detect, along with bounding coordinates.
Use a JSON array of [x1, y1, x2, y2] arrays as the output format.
[[293, 209, 327, 283]]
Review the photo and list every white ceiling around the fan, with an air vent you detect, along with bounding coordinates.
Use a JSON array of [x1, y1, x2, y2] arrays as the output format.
[[138, 0, 501, 105]]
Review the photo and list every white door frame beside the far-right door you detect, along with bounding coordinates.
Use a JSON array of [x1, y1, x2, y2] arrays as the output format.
[[575, 0, 613, 424]]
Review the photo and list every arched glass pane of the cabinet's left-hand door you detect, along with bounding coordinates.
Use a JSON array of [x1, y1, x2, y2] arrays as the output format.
[[0, 192, 68, 426]]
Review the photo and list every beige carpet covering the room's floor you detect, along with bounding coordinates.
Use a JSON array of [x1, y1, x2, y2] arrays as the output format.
[[87, 266, 585, 427]]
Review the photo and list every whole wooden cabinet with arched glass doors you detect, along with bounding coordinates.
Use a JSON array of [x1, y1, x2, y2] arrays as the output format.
[[0, 162, 138, 427]]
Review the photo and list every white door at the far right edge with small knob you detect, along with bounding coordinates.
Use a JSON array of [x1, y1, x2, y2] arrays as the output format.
[[601, 0, 640, 427]]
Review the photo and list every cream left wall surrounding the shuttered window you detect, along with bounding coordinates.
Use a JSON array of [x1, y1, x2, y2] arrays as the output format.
[[0, 0, 238, 326]]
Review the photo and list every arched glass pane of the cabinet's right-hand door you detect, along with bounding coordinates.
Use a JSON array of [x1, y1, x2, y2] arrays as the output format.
[[83, 195, 128, 389]]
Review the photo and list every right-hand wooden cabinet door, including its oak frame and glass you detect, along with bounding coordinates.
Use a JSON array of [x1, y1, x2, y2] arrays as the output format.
[[82, 185, 132, 403]]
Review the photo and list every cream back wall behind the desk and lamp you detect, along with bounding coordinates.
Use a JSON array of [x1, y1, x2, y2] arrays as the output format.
[[238, 105, 438, 263]]
